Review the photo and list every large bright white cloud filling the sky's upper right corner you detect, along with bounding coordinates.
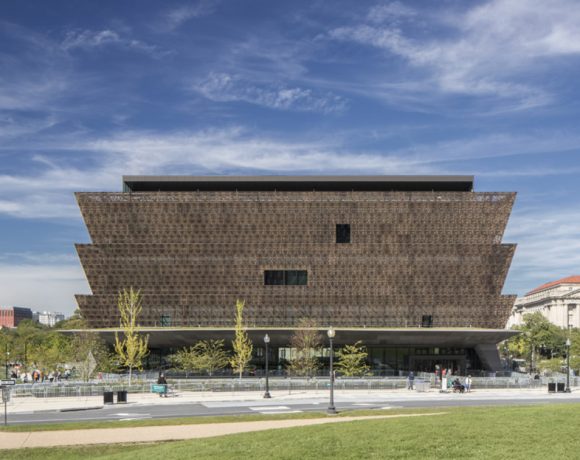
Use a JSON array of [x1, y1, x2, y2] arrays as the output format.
[[329, 0, 580, 109]]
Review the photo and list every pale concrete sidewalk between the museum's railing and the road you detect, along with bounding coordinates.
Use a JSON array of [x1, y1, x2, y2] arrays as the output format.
[[3, 389, 580, 414]]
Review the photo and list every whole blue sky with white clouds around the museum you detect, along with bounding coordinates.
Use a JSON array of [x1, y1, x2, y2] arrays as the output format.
[[0, 0, 580, 313]]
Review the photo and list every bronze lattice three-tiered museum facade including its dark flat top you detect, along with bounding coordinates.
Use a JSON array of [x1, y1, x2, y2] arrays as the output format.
[[76, 177, 515, 329]]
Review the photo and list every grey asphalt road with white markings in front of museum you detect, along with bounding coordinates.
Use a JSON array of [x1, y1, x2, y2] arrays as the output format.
[[2, 395, 580, 426]]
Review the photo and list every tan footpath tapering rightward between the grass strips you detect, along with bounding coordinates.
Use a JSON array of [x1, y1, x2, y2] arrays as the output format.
[[0, 412, 445, 452]]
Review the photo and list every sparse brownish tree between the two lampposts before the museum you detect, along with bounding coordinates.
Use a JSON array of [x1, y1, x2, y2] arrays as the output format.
[[288, 318, 322, 376]]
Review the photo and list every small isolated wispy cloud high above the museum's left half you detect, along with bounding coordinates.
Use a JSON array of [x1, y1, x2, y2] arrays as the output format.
[[192, 73, 346, 113]]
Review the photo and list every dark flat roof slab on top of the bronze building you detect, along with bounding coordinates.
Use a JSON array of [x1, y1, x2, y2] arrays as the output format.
[[123, 176, 474, 192]]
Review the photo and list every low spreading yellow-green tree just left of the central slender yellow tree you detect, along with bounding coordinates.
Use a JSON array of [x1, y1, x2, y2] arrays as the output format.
[[170, 340, 230, 375]]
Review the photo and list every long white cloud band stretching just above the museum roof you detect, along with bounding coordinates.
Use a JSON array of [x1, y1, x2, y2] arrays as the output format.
[[0, 127, 580, 220]]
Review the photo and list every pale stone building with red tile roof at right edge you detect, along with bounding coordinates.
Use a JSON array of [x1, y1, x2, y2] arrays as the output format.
[[507, 275, 580, 328]]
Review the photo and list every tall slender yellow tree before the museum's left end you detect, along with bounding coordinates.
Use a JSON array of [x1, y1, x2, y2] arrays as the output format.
[[115, 287, 149, 385]]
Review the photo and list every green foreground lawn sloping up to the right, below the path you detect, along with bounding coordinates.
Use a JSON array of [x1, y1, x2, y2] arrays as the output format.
[[0, 404, 580, 460]]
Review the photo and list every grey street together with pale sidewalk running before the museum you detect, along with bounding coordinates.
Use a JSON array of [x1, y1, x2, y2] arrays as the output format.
[[9, 392, 580, 424]]
